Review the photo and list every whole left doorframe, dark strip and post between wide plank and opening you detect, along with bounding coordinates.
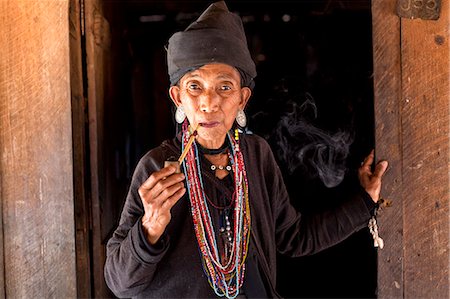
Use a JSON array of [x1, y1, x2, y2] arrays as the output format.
[[69, 0, 112, 298]]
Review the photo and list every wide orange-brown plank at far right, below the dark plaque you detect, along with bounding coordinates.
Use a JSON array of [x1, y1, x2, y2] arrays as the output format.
[[401, 1, 450, 298]]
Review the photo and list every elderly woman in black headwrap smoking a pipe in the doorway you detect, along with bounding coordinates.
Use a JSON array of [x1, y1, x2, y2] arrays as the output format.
[[105, 2, 387, 298]]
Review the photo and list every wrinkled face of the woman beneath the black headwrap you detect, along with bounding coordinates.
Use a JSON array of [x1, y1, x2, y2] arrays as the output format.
[[169, 63, 251, 148]]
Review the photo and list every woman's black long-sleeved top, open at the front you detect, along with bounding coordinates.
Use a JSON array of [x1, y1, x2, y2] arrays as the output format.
[[105, 135, 375, 298]]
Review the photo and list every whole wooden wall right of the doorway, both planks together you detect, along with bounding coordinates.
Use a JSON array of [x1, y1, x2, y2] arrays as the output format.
[[372, 0, 450, 298]]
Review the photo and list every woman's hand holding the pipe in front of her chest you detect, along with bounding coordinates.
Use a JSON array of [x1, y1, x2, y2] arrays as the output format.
[[138, 166, 186, 244]]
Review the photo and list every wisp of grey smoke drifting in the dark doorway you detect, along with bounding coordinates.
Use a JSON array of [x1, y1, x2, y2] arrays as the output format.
[[273, 96, 353, 188]]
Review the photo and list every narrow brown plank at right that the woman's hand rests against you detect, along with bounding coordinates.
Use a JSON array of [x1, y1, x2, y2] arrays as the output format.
[[372, 0, 404, 298]]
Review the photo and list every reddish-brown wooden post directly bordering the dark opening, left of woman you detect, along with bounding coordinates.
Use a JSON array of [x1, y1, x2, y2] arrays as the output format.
[[84, 0, 111, 298]]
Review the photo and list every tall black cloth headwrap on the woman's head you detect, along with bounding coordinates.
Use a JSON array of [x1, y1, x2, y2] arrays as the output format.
[[167, 1, 256, 88]]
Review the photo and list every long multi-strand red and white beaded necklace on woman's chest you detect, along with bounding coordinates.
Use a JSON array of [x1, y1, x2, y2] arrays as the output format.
[[182, 122, 250, 299]]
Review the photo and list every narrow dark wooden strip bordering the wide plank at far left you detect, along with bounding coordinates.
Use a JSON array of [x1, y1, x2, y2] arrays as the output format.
[[69, 0, 92, 298]]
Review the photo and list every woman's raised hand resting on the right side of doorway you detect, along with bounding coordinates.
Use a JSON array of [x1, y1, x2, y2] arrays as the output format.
[[358, 150, 388, 202]]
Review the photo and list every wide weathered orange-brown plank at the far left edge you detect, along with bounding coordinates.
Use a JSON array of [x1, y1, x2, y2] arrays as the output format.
[[0, 0, 76, 298]]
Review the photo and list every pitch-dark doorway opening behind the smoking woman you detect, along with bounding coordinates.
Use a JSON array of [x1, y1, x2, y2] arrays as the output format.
[[103, 0, 376, 298]]
